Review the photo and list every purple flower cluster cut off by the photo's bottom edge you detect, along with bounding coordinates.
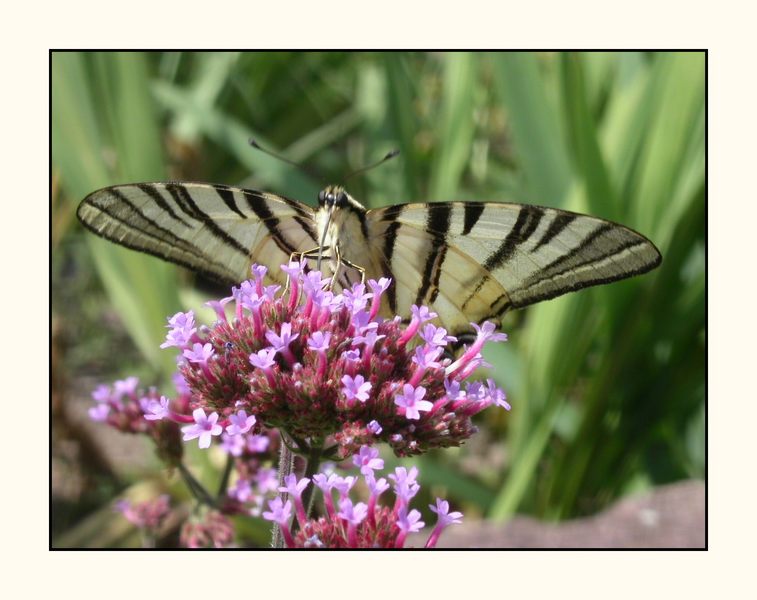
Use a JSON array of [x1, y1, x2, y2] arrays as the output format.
[[263, 447, 463, 548]]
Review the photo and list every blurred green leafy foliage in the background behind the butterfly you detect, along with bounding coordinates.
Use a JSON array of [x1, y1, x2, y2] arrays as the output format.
[[52, 52, 706, 536]]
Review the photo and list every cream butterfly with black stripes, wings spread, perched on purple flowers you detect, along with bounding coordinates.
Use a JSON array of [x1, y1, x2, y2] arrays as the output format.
[[77, 182, 662, 335]]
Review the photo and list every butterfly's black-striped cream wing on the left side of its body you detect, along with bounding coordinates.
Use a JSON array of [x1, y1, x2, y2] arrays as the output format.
[[77, 182, 318, 284]]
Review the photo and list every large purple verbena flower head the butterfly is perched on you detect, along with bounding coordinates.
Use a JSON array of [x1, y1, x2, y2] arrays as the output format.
[[165, 262, 509, 457]]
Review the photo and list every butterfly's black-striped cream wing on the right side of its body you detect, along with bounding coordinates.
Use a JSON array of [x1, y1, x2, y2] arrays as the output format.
[[368, 202, 661, 333]]
